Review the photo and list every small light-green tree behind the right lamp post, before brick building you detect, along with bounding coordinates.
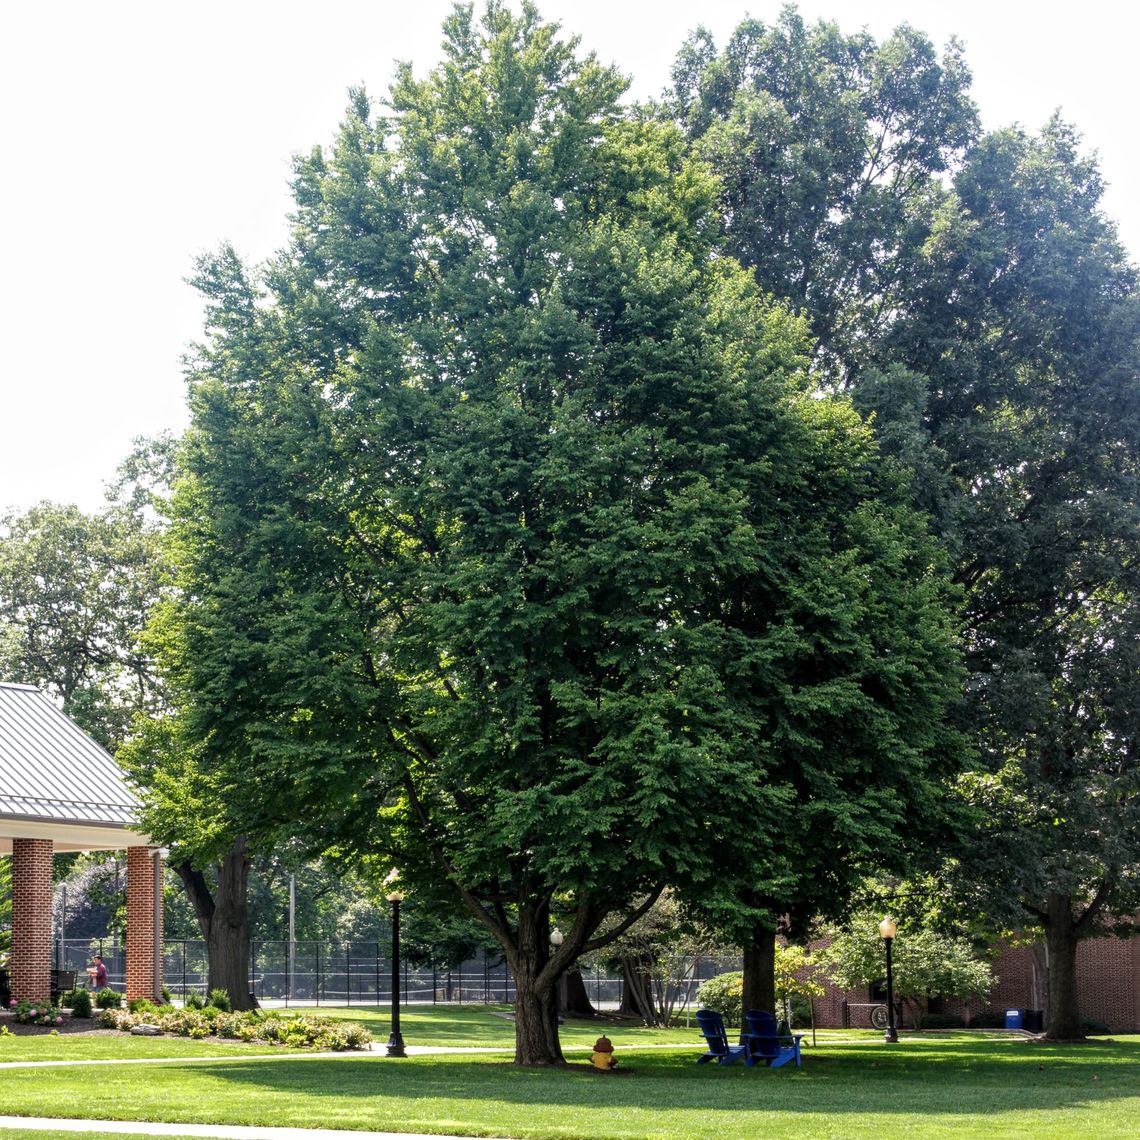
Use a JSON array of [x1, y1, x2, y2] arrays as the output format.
[[819, 913, 994, 1027]]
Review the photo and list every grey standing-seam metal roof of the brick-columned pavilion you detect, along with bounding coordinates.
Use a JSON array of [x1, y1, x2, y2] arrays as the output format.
[[0, 682, 139, 827]]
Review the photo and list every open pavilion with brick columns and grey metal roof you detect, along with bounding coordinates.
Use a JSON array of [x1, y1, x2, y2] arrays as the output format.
[[0, 682, 163, 1001]]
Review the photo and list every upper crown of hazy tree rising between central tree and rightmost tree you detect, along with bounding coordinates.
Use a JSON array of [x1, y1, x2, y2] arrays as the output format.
[[665, 5, 978, 381]]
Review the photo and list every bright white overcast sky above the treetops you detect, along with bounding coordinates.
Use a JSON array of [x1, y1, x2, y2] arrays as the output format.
[[0, 0, 1140, 514]]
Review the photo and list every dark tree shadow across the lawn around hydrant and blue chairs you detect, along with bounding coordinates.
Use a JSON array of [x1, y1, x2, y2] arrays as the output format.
[[196, 1041, 1140, 1119]]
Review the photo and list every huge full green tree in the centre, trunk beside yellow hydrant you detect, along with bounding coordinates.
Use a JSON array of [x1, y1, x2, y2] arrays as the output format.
[[147, 3, 953, 1065]]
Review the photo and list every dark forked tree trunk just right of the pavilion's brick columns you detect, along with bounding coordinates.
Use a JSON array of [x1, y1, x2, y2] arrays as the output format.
[[174, 836, 258, 1009]]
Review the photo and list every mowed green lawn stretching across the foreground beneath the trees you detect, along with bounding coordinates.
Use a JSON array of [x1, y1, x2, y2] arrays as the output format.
[[0, 1009, 1140, 1140]]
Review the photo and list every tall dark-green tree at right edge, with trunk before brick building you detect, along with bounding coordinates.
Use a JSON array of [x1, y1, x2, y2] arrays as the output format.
[[875, 120, 1140, 1039]]
